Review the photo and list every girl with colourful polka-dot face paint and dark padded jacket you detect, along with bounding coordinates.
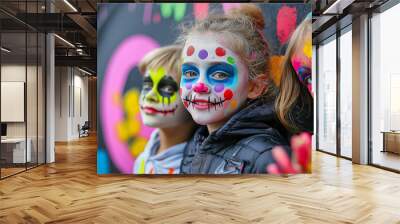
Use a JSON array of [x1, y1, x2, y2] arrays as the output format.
[[180, 4, 312, 174]]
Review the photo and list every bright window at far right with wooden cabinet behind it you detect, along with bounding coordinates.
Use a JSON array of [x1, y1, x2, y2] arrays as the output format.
[[370, 4, 400, 172]]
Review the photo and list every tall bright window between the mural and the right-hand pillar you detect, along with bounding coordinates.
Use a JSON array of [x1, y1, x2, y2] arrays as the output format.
[[315, 25, 352, 159]]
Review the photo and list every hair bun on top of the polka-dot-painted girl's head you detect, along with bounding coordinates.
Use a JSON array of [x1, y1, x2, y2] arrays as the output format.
[[227, 3, 265, 30]]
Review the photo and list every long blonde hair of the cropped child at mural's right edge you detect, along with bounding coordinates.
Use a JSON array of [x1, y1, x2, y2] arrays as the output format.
[[275, 18, 313, 132]]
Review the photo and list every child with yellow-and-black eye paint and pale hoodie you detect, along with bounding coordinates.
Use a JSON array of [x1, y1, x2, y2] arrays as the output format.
[[133, 45, 195, 174]]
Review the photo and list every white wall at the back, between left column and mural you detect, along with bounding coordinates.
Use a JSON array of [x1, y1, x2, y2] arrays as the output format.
[[55, 67, 88, 141]]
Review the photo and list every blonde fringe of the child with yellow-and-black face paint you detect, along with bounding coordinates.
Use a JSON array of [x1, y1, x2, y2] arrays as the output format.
[[139, 45, 182, 81]]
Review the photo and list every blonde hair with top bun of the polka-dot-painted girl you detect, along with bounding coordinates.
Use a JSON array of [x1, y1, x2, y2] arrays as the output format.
[[178, 3, 270, 79]]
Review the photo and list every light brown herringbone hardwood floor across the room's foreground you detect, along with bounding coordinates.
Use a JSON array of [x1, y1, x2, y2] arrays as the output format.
[[0, 134, 400, 224]]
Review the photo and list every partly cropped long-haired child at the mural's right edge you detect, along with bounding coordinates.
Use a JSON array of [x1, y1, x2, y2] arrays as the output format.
[[276, 13, 313, 136]]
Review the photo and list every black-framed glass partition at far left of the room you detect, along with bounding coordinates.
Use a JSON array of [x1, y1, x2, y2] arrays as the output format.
[[0, 1, 46, 179]]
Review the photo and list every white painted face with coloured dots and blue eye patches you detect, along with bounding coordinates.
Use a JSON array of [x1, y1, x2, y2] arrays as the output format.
[[180, 35, 248, 125]]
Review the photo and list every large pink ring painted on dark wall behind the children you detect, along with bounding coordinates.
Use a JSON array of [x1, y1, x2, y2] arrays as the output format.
[[100, 35, 159, 174]]
